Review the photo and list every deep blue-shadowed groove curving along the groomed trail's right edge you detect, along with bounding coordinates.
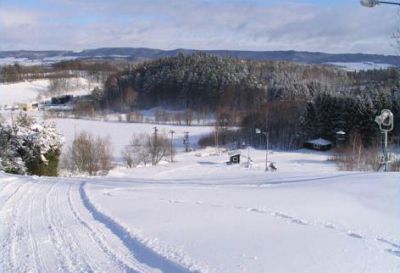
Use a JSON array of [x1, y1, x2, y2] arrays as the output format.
[[79, 182, 192, 273]]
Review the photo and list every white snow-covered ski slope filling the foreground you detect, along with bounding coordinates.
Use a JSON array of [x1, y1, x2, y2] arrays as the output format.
[[0, 149, 400, 273]]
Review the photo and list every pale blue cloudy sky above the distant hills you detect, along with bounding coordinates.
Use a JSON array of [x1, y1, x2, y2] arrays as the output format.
[[0, 0, 400, 54]]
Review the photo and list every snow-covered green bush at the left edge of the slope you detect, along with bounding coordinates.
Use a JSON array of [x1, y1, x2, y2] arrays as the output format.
[[0, 114, 63, 176]]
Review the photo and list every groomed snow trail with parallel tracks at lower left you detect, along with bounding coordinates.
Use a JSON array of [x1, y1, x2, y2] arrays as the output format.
[[0, 177, 191, 273]]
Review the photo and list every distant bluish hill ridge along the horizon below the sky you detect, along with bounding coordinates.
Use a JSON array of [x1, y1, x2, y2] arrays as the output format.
[[0, 48, 400, 66]]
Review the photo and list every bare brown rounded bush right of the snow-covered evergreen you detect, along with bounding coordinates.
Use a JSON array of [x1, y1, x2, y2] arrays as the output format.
[[63, 132, 113, 175]]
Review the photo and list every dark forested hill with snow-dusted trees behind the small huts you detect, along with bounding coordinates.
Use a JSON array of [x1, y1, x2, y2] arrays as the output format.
[[96, 53, 400, 149]]
